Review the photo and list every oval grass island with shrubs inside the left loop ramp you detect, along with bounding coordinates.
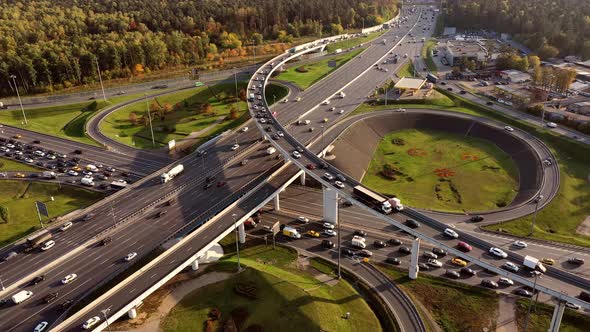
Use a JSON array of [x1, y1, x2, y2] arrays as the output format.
[[100, 82, 248, 149]]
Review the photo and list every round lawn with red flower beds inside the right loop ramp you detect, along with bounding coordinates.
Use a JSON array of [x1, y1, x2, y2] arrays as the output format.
[[362, 129, 518, 212]]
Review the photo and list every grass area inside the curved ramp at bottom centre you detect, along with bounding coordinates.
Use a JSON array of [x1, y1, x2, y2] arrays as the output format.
[[160, 246, 382, 332]]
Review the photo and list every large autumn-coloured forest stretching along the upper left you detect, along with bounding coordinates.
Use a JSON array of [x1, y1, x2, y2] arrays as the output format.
[[0, 0, 398, 96]]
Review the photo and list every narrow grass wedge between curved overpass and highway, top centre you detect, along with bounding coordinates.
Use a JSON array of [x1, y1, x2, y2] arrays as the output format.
[[276, 48, 365, 89]]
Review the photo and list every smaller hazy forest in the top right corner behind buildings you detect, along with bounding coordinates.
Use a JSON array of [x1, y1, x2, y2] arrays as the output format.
[[445, 0, 590, 60]]
